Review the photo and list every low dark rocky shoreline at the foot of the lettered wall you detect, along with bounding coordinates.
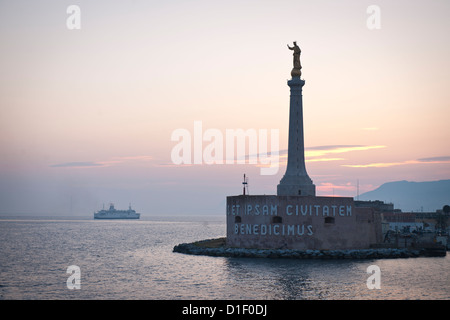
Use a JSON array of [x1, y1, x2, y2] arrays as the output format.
[[173, 238, 445, 259]]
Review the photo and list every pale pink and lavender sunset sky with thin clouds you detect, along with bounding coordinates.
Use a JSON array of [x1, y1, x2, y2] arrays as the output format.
[[0, 0, 450, 215]]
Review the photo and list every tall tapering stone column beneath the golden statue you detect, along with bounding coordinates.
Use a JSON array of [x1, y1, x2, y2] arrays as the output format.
[[277, 74, 316, 196]]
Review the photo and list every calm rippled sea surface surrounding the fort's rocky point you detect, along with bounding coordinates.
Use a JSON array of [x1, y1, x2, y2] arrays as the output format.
[[0, 216, 450, 300]]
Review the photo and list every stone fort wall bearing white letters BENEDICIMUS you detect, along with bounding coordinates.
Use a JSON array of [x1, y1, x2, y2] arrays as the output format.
[[226, 195, 382, 250]]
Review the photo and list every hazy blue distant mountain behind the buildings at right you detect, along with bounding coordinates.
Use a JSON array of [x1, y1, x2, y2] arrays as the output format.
[[359, 180, 450, 212]]
